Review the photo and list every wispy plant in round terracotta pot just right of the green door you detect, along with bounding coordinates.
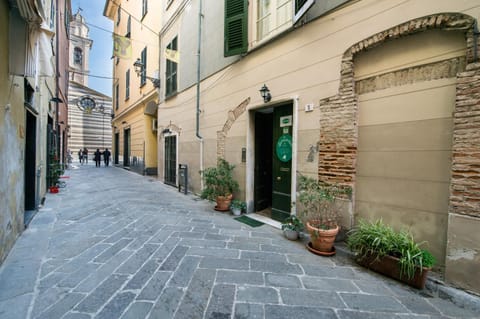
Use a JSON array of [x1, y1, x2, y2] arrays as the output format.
[[297, 175, 351, 256]]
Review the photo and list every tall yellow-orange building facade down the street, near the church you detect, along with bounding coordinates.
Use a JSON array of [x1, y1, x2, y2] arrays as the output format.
[[104, 0, 162, 175]]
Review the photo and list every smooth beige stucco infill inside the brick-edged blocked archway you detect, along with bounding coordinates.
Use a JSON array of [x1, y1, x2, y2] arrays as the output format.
[[354, 30, 466, 268]]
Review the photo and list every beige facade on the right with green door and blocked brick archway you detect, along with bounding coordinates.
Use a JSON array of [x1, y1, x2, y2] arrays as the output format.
[[153, 0, 480, 293]]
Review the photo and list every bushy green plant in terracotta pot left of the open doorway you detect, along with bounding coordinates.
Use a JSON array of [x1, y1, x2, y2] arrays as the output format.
[[200, 158, 239, 211]]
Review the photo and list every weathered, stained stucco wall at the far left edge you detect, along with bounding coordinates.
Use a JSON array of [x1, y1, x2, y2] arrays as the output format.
[[0, 1, 25, 263]]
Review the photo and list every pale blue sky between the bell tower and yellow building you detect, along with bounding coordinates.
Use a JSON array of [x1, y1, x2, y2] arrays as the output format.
[[72, 0, 113, 96]]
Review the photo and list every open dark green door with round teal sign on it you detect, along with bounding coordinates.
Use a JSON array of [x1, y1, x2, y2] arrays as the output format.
[[272, 104, 293, 222]]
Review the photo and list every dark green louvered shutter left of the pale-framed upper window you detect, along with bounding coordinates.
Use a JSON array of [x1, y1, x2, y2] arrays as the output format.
[[224, 0, 248, 57]]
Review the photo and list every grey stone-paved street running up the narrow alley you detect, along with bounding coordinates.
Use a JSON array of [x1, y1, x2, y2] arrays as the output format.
[[0, 163, 478, 319]]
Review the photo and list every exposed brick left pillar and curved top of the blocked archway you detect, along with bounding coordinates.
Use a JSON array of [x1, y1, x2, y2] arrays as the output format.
[[318, 13, 475, 187]]
